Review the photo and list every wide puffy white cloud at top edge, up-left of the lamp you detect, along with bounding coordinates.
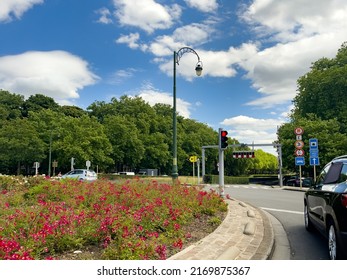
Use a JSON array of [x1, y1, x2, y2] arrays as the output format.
[[113, 0, 181, 33]]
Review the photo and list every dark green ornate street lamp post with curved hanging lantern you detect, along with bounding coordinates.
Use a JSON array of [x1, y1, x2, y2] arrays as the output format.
[[172, 47, 202, 182]]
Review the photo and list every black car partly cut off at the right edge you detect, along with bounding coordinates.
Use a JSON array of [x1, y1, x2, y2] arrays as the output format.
[[304, 155, 347, 260]]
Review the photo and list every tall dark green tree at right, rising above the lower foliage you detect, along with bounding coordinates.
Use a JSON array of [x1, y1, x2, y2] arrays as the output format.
[[292, 42, 347, 133]]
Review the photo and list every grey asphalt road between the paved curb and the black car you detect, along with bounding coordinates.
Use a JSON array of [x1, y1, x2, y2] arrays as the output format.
[[225, 185, 329, 260]]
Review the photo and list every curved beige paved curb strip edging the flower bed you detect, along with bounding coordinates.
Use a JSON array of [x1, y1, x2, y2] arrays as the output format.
[[169, 199, 274, 260]]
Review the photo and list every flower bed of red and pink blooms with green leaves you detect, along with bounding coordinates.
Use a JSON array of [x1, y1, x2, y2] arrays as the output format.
[[0, 177, 227, 260]]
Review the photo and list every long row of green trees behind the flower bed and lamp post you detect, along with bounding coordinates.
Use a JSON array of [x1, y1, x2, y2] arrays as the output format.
[[0, 90, 277, 175]]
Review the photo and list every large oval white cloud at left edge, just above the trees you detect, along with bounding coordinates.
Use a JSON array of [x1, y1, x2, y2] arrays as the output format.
[[0, 51, 98, 102]]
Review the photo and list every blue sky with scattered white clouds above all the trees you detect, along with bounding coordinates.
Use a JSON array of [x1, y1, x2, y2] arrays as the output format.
[[0, 0, 347, 152]]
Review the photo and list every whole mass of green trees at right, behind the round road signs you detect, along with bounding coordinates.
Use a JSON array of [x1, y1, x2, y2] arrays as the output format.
[[278, 42, 347, 176]]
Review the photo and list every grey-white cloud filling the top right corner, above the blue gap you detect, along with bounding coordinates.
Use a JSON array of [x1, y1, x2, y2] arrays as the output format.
[[243, 0, 347, 41]]
